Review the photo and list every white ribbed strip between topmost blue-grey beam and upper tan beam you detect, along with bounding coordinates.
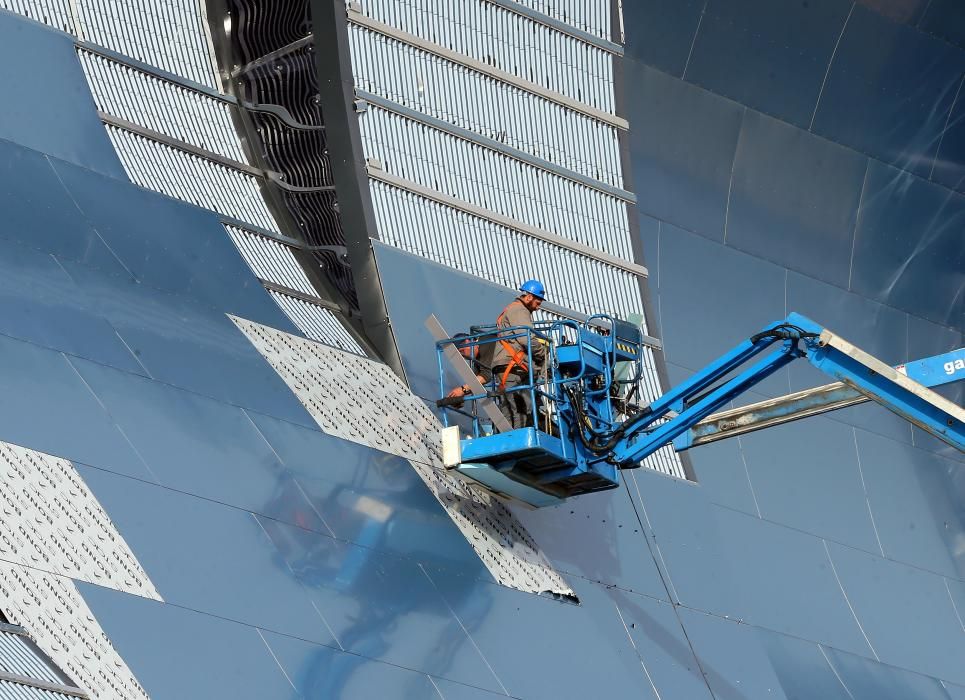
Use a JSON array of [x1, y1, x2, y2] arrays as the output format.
[[361, 0, 614, 113]]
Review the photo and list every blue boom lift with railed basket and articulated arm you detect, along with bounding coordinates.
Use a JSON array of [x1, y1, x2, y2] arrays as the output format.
[[426, 313, 965, 507]]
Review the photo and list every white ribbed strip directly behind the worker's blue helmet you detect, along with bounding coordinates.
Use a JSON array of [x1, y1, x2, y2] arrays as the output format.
[[369, 180, 641, 318]]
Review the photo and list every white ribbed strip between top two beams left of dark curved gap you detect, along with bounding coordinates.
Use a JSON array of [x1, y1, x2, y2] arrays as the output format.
[[77, 49, 248, 163]]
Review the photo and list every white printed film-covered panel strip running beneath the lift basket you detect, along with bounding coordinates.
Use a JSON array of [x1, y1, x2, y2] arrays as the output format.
[[231, 316, 573, 595]]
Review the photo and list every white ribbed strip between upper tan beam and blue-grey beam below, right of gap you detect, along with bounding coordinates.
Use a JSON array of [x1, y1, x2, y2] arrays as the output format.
[[349, 24, 623, 187]]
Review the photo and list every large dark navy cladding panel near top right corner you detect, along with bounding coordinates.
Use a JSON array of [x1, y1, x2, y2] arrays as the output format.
[[812, 5, 965, 177]]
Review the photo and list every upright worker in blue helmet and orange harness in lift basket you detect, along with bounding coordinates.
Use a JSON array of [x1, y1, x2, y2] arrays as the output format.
[[493, 280, 546, 428]]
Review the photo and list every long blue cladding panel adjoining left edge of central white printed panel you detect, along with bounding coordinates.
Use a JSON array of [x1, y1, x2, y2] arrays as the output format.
[[56, 263, 316, 427]]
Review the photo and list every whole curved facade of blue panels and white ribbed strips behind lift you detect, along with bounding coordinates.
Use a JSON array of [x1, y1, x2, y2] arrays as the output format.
[[0, 0, 965, 700]]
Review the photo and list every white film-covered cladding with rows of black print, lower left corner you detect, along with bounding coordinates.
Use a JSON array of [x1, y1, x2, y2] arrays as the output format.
[[0, 442, 161, 698]]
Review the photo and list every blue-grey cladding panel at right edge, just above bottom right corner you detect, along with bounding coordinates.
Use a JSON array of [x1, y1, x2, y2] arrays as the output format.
[[828, 543, 965, 683]]
